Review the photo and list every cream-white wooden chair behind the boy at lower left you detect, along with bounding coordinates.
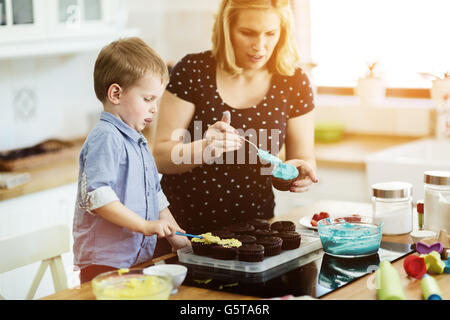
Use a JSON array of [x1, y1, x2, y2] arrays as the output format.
[[0, 225, 70, 300]]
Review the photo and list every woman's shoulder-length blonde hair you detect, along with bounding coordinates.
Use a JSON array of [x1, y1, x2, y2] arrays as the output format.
[[212, 0, 300, 76]]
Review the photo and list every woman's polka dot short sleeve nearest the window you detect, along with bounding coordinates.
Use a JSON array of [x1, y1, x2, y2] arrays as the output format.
[[288, 68, 314, 118]]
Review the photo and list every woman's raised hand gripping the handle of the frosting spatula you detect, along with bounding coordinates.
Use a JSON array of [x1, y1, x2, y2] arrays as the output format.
[[204, 114, 242, 161]]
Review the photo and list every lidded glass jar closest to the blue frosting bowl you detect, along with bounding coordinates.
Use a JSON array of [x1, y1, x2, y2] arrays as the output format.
[[372, 181, 413, 235]]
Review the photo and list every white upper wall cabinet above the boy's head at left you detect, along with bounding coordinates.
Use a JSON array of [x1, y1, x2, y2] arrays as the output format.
[[0, 0, 137, 59]]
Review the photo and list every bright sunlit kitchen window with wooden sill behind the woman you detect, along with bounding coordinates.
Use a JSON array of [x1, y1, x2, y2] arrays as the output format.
[[301, 0, 450, 98]]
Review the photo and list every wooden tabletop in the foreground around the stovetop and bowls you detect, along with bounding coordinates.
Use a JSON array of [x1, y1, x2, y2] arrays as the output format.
[[44, 201, 450, 300]]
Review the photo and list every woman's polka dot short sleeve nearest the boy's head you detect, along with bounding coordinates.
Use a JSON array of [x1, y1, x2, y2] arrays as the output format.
[[167, 54, 201, 104]]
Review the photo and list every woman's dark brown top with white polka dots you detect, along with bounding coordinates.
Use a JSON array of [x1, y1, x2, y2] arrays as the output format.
[[161, 51, 314, 234]]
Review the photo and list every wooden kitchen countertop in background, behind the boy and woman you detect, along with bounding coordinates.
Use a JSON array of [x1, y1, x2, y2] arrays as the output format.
[[0, 135, 417, 201]]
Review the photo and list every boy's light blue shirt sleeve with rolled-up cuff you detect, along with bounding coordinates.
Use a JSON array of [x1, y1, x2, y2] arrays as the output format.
[[82, 132, 123, 210]]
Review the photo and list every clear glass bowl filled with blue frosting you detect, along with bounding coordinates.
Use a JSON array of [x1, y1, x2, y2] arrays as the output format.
[[317, 217, 383, 258]]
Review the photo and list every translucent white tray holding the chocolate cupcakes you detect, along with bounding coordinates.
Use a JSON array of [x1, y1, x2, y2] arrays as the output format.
[[177, 235, 322, 273]]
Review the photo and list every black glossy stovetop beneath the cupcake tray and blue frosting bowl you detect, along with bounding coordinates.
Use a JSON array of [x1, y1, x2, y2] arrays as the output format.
[[177, 242, 414, 298]]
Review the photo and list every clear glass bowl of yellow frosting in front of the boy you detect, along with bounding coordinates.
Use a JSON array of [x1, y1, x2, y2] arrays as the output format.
[[92, 269, 173, 300]]
